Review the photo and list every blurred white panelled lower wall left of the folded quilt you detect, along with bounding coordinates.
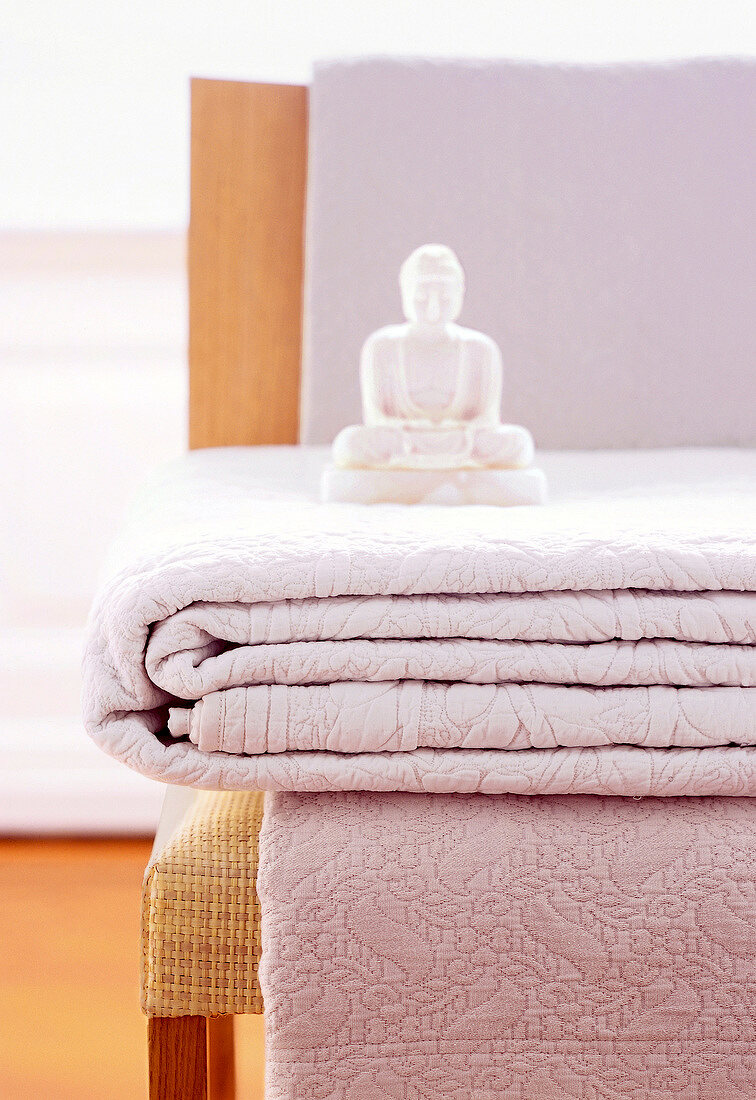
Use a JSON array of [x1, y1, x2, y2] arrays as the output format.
[[0, 233, 186, 832]]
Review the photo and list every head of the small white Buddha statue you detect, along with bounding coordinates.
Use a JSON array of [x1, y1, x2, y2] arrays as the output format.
[[399, 244, 464, 325]]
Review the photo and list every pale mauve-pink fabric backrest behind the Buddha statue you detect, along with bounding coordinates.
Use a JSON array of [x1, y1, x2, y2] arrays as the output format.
[[302, 59, 756, 448]]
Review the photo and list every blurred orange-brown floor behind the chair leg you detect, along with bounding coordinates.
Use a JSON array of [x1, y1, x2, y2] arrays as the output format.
[[0, 839, 263, 1100]]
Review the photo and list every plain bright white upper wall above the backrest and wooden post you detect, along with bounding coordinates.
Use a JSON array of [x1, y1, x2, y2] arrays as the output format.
[[0, 0, 756, 229]]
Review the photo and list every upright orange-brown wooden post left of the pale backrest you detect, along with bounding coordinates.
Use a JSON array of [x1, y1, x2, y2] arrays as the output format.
[[189, 79, 307, 448]]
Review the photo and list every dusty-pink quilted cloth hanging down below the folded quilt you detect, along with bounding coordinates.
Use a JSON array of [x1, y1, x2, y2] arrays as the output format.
[[258, 793, 756, 1100]]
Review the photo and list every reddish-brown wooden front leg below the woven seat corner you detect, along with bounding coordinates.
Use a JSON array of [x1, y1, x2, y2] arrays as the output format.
[[147, 1016, 207, 1100]]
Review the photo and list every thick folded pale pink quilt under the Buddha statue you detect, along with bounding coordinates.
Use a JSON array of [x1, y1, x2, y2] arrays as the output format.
[[85, 448, 756, 795]]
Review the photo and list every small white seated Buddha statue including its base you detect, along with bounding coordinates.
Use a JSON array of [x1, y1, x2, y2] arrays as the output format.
[[324, 244, 545, 504]]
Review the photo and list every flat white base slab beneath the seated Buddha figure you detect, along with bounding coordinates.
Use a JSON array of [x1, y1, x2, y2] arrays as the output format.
[[320, 465, 546, 507]]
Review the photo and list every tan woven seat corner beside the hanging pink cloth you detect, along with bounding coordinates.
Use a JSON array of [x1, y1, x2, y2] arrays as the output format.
[[142, 791, 263, 1016]]
